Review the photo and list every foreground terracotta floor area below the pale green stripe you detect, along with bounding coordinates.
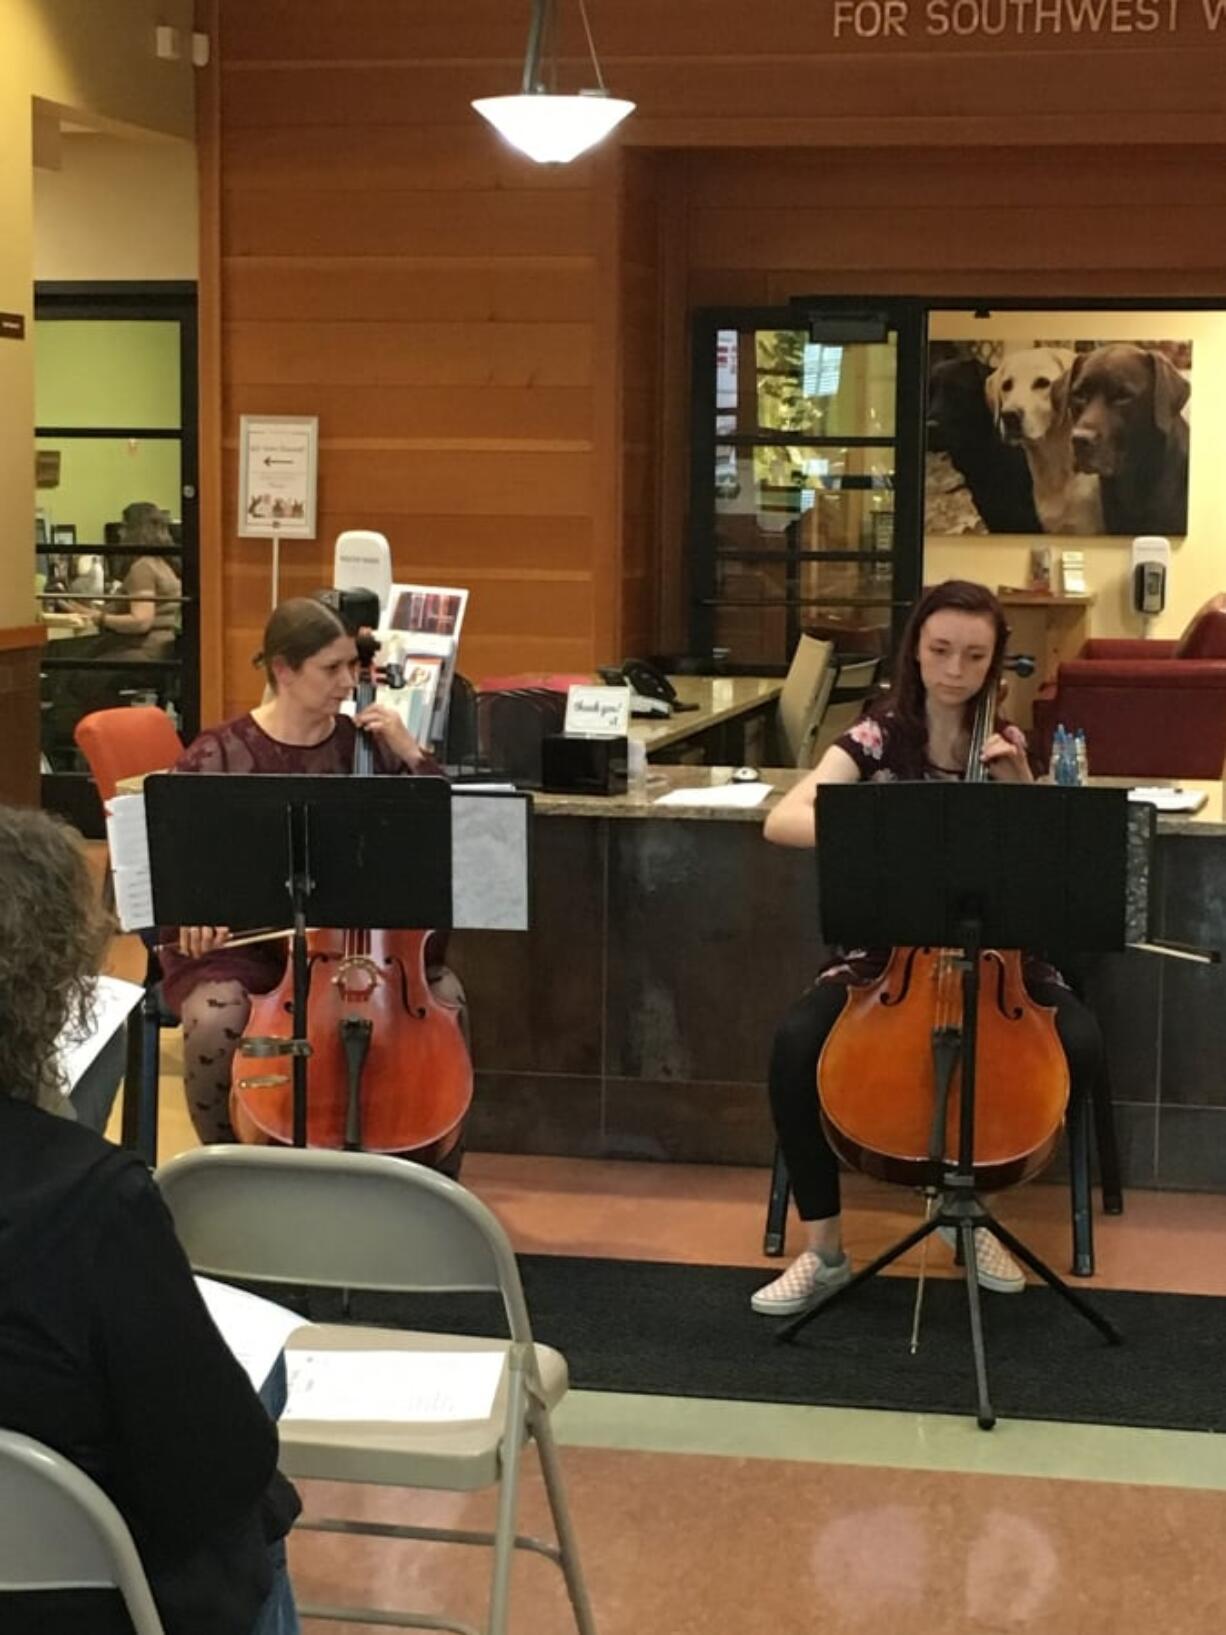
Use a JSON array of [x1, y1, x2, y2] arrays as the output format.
[[291, 1449, 1226, 1635]]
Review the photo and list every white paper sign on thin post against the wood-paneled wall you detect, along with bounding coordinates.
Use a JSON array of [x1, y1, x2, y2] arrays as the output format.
[[239, 414, 319, 607]]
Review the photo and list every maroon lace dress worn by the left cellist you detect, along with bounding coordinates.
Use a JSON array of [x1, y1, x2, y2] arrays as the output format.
[[162, 714, 443, 1012]]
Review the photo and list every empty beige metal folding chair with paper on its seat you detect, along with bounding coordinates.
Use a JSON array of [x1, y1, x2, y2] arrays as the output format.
[[157, 1146, 595, 1635]]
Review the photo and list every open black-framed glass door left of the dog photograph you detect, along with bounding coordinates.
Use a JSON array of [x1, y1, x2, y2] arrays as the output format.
[[690, 302, 924, 674]]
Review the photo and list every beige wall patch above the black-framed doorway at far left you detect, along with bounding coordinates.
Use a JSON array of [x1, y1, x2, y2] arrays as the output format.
[[34, 132, 199, 281]]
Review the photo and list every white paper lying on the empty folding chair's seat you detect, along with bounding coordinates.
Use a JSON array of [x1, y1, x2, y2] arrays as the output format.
[[281, 1351, 505, 1422]]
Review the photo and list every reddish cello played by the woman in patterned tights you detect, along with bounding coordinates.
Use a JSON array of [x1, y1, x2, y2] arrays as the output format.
[[230, 631, 472, 1167]]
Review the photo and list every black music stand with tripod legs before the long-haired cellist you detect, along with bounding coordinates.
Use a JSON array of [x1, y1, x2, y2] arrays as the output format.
[[776, 783, 1128, 1431]]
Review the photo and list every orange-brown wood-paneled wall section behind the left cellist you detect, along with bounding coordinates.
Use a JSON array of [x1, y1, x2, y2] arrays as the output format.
[[206, 0, 620, 716]]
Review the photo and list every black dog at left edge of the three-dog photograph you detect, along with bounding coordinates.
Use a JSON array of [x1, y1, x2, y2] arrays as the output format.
[[928, 358, 1040, 533]]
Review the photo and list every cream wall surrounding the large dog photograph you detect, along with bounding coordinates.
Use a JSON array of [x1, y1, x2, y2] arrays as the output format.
[[924, 312, 1226, 638]]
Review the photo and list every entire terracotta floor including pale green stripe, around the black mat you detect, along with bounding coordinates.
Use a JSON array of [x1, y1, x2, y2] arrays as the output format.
[[100, 909, 1226, 1635]]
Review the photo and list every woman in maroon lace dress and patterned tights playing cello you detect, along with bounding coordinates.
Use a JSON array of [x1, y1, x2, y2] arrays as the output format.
[[162, 597, 454, 1143]]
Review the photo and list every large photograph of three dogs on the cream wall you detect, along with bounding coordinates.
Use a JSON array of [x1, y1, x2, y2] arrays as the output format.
[[925, 335, 1192, 536]]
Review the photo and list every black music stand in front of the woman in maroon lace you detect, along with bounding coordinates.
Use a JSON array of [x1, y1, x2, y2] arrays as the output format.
[[144, 773, 451, 1146]]
